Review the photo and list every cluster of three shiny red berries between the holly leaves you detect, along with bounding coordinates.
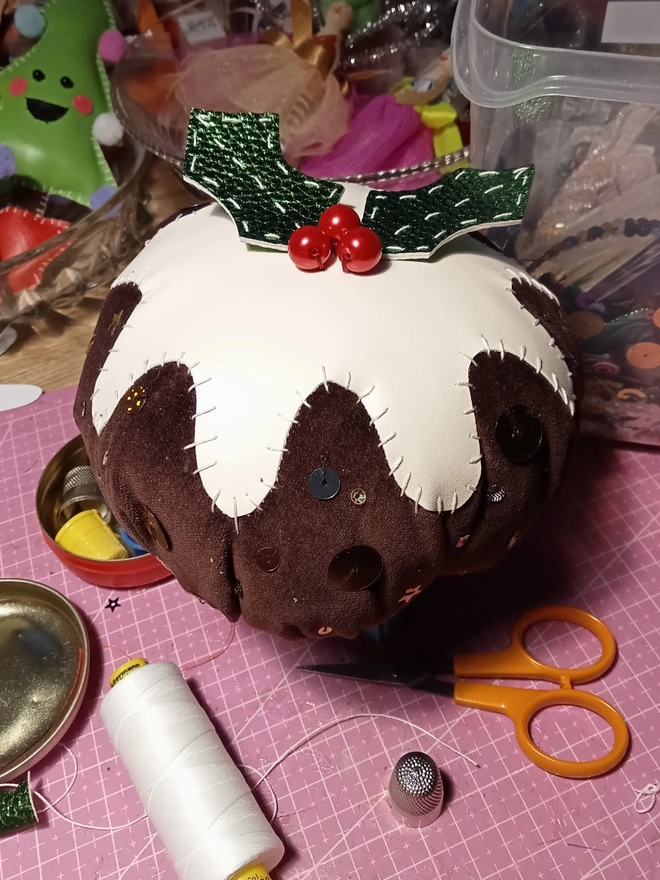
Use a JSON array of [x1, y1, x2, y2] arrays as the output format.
[[289, 205, 383, 274]]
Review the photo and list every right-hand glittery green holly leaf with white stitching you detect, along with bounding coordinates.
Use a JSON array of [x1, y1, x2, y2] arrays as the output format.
[[362, 165, 534, 260]]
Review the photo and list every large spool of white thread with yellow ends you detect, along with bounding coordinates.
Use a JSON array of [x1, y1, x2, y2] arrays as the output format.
[[101, 661, 284, 880]]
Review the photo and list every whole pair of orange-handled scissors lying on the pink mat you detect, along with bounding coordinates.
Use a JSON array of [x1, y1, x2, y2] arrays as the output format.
[[299, 605, 629, 779]]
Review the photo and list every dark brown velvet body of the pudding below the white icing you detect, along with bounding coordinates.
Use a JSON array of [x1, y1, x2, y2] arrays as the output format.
[[75, 258, 580, 638]]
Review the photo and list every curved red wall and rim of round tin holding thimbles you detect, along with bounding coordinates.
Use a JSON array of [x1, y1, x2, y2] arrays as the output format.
[[36, 435, 171, 589]]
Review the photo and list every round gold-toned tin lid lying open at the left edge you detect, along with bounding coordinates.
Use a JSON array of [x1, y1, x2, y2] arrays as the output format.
[[0, 580, 89, 783]]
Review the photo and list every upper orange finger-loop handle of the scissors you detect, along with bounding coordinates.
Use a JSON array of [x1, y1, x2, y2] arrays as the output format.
[[454, 605, 616, 688]]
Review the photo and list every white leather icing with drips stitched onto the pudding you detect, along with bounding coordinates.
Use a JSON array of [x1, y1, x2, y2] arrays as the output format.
[[92, 205, 574, 517]]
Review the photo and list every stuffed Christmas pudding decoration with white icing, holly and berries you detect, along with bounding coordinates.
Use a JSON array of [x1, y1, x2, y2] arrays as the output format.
[[75, 111, 580, 638]]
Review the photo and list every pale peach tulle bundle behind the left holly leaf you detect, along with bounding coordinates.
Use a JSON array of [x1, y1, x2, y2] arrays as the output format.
[[176, 43, 351, 166]]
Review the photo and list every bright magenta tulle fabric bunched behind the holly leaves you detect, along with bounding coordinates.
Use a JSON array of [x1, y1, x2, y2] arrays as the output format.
[[302, 95, 438, 190]]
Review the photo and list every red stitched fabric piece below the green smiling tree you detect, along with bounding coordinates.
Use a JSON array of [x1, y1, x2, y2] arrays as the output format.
[[0, 207, 71, 293]]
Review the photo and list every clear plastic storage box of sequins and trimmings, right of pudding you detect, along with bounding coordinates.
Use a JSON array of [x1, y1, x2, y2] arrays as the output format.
[[452, 0, 660, 445]]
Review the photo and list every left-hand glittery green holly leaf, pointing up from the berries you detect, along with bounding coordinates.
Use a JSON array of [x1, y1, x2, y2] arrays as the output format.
[[183, 110, 344, 250]]
